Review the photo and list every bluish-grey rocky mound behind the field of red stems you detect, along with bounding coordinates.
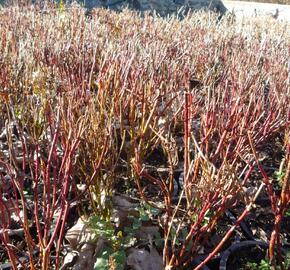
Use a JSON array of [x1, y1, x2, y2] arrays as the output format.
[[84, 0, 226, 16]]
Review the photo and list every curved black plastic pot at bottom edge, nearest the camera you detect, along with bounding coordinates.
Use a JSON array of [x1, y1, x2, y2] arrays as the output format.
[[219, 240, 268, 270]]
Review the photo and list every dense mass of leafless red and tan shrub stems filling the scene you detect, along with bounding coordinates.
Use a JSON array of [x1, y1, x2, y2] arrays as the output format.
[[0, 6, 290, 269]]
